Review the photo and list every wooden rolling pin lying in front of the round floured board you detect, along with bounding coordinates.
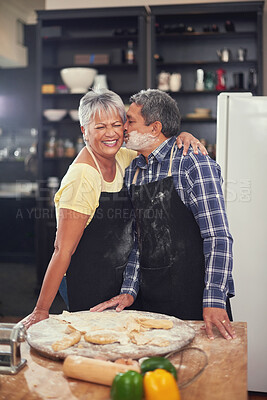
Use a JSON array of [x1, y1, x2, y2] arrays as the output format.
[[63, 356, 140, 386]]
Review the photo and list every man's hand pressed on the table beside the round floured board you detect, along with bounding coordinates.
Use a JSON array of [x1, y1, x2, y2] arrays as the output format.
[[203, 307, 236, 340]]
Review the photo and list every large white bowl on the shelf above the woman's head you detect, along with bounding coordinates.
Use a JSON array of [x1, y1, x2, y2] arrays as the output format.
[[60, 67, 97, 93]]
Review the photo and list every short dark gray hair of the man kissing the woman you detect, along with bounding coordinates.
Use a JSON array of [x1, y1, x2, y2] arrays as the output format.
[[130, 89, 181, 137]]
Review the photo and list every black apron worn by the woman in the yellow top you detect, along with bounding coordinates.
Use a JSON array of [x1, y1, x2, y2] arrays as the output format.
[[67, 148, 134, 311]]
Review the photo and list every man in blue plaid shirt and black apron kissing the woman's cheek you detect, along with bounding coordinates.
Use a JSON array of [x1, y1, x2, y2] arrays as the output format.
[[92, 89, 235, 339]]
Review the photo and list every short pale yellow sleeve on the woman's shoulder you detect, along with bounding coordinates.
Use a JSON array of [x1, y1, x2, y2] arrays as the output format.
[[55, 164, 101, 220]]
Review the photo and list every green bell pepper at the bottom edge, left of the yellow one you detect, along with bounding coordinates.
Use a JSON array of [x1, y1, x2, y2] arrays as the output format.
[[110, 371, 143, 400]]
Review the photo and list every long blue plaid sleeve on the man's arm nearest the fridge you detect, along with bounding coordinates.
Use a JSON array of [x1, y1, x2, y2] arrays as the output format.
[[184, 153, 234, 308]]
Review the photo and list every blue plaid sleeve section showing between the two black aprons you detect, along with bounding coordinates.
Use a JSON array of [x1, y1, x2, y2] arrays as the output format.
[[121, 228, 140, 299]]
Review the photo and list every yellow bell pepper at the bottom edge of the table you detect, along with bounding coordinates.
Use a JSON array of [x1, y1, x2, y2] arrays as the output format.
[[144, 369, 181, 400]]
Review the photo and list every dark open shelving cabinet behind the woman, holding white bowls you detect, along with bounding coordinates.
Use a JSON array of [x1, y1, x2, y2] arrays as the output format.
[[37, 7, 146, 180]]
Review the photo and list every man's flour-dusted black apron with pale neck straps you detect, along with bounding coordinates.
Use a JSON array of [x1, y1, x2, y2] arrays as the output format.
[[131, 142, 205, 320]]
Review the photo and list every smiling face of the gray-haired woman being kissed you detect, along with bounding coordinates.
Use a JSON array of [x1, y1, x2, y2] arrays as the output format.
[[85, 111, 123, 158]]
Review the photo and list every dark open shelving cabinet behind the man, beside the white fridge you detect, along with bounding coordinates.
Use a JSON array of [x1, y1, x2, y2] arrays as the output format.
[[151, 1, 264, 148]]
